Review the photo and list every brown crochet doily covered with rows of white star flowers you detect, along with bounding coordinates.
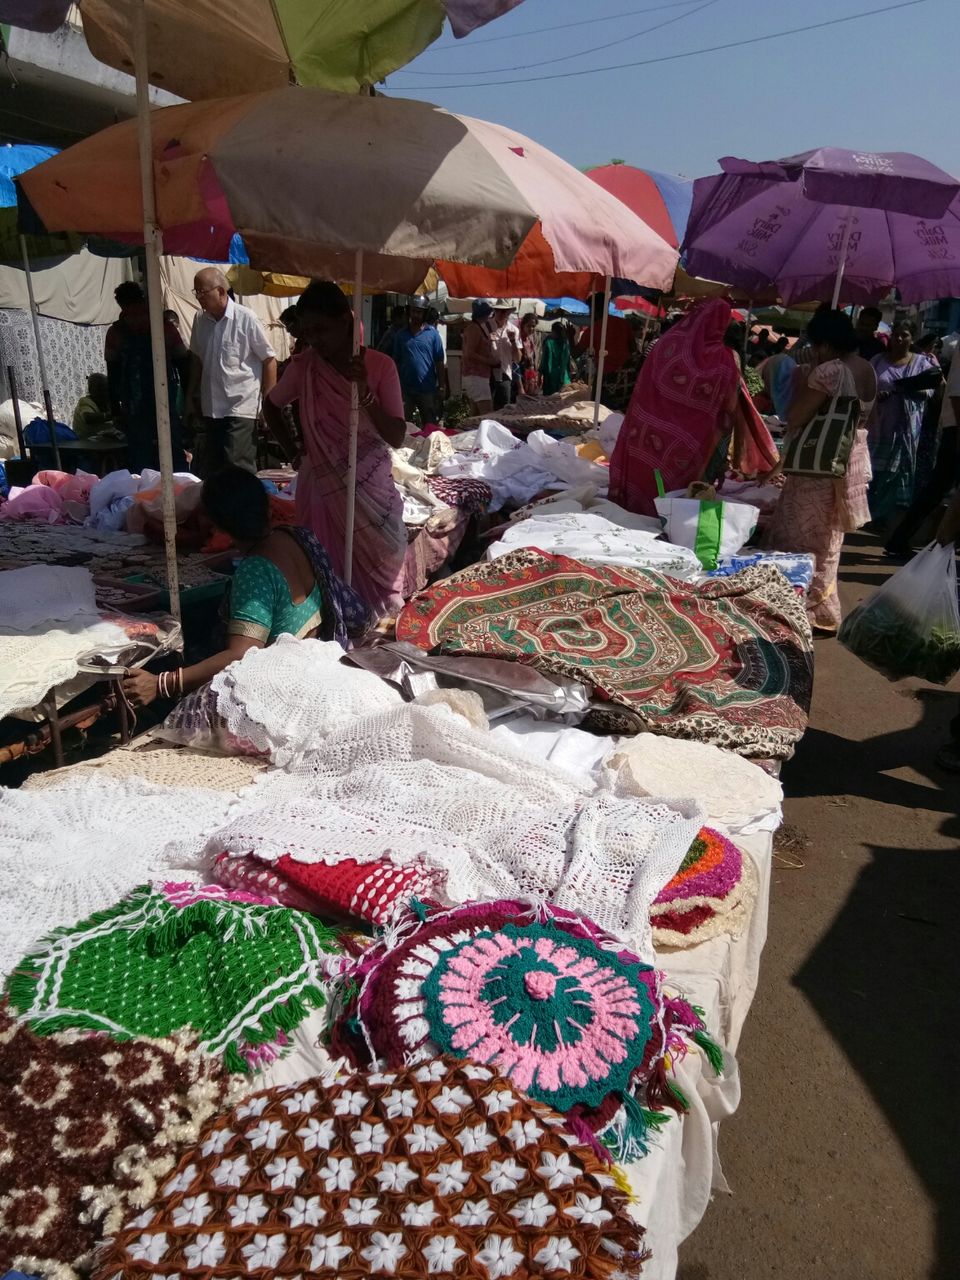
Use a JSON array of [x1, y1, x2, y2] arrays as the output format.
[[93, 1060, 643, 1280]]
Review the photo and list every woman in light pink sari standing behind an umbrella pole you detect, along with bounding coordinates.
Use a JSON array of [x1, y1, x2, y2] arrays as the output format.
[[264, 280, 407, 613]]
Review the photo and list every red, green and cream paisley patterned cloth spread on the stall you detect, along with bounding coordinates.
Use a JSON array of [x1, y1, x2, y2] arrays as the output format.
[[397, 549, 813, 759]]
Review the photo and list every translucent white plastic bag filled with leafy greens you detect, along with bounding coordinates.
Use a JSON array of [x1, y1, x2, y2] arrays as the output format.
[[840, 543, 960, 685]]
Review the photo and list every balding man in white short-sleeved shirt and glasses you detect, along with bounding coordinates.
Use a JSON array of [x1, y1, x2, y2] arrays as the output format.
[[189, 266, 276, 476]]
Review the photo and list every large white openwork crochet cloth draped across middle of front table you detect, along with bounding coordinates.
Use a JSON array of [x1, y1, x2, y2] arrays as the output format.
[[210, 705, 703, 957]]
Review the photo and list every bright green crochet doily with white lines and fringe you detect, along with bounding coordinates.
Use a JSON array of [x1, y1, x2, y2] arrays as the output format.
[[8, 884, 337, 1071]]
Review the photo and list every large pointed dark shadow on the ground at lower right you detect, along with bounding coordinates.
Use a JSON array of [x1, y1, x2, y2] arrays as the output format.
[[798, 845, 960, 1280]]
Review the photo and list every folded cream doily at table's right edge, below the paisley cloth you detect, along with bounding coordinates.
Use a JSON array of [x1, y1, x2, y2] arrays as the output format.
[[604, 733, 783, 823]]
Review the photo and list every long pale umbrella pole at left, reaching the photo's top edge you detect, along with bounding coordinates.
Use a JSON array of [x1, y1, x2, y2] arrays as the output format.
[[133, 0, 180, 622]]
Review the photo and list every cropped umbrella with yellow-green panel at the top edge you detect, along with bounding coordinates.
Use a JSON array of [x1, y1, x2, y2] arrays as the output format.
[[0, 0, 522, 99]]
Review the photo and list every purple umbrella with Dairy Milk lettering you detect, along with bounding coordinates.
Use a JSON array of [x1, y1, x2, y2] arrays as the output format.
[[684, 148, 960, 306]]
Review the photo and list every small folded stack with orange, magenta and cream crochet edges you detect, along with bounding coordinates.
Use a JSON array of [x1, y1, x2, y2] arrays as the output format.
[[650, 827, 756, 947]]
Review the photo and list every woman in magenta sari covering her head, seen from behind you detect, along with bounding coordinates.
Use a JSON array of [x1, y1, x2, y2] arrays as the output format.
[[611, 298, 740, 516]]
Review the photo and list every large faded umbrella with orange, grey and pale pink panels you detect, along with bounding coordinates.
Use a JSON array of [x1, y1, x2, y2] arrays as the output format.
[[20, 88, 677, 297]]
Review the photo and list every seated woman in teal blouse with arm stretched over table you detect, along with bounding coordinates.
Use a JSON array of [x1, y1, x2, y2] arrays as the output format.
[[123, 466, 370, 707]]
